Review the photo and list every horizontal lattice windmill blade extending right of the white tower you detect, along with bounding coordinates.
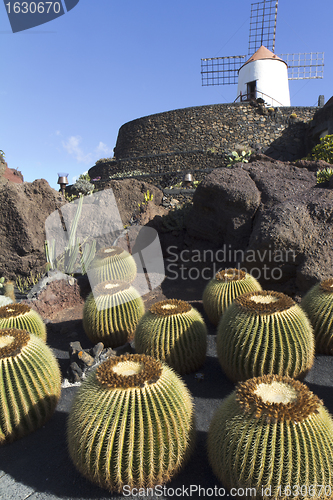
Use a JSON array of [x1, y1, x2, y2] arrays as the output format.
[[279, 52, 324, 80]]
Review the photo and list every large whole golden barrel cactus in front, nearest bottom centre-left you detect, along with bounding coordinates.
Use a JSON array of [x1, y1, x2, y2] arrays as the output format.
[[67, 354, 195, 492]]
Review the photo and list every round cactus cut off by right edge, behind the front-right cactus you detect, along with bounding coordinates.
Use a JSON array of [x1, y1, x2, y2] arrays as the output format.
[[301, 278, 333, 355]]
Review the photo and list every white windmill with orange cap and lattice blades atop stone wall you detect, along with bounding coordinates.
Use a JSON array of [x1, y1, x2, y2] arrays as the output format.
[[201, 0, 324, 106]]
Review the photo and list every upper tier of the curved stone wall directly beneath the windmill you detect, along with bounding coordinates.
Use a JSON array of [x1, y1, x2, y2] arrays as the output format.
[[115, 103, 317, 160]]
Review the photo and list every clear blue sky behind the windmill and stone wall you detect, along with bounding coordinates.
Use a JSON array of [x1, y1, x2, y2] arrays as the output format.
[[0, 0, 333, 189]]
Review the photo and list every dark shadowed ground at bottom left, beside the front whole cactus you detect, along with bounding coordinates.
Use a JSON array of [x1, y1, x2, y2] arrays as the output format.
[[0, 398, 123, 500]]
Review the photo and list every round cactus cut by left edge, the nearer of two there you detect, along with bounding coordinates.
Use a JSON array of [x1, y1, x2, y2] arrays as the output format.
[[0, 328, 61, 444]]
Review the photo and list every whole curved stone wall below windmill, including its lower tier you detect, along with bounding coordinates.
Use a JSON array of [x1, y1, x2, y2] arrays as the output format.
[[89, 103, 318, 187]]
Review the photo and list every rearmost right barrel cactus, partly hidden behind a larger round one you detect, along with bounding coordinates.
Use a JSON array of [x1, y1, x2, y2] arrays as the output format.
[[202, 269, 262, 326]]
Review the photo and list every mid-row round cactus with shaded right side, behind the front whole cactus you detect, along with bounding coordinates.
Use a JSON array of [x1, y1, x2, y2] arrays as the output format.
[[134, 299, 207, 374]]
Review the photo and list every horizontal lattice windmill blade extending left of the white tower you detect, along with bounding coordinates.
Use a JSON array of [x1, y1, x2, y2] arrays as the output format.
[[201, 56, 246, 86]]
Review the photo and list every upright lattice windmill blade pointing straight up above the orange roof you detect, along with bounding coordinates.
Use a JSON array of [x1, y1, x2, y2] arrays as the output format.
[[248, 0, 278, 55]]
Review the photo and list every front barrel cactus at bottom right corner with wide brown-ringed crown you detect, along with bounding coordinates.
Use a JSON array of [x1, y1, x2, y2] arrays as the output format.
[[208, 375, 333, 500]]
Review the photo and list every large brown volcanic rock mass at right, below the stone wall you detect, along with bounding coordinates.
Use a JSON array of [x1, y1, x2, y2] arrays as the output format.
[[187, 155, 333, 294]]
